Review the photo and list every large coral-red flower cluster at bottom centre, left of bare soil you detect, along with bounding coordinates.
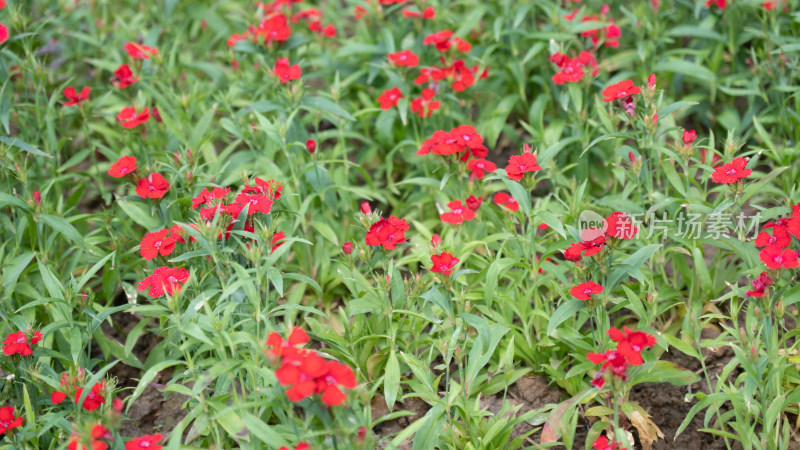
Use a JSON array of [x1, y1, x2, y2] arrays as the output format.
[[267, 327, 356, 407]]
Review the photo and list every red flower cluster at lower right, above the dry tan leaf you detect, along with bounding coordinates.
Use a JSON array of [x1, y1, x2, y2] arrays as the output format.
[[586, 327, 656, 389]]
